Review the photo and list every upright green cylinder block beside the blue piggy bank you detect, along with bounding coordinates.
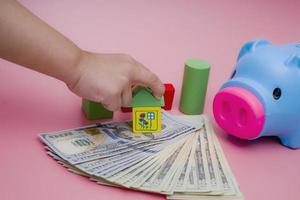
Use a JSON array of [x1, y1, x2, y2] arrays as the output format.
[[179, 59, 210, 115]]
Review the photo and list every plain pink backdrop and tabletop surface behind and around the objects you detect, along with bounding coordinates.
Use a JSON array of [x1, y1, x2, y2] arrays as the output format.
[[0, 0, 300, 200]]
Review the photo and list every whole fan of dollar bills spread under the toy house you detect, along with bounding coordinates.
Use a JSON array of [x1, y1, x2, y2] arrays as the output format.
[[39, 112, 243, 199]]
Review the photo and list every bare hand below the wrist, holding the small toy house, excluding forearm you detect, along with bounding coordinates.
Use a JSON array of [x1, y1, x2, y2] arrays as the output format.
[[67, 52, 164, 111]]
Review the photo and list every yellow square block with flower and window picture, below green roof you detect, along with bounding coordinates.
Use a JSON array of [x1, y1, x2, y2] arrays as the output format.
[[132, 107, 161, 133]]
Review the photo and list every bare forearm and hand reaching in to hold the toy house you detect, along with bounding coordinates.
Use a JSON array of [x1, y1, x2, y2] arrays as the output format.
[[0, 1, 164, 111]]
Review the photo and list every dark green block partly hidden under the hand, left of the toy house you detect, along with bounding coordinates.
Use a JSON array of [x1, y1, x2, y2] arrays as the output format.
[[82, 99, 114, 120]]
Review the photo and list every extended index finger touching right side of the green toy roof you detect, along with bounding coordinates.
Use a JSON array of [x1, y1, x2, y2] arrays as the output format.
[[132, 62, 165, 99]]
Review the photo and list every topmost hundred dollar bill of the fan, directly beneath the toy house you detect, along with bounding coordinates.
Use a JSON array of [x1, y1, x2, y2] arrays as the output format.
[[39, 112, 197, 164]]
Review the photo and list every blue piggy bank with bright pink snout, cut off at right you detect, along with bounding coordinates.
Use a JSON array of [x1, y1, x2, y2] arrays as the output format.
[[213, 39, 300, 148]]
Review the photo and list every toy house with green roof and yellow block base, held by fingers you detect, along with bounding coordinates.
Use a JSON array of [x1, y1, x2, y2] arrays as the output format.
[[130, 86, 165, 133]]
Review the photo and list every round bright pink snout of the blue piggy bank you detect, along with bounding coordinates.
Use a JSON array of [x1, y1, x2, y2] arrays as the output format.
[[213, 86, 265, 139]]
